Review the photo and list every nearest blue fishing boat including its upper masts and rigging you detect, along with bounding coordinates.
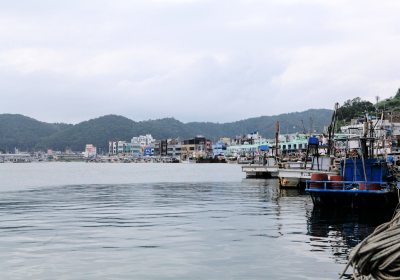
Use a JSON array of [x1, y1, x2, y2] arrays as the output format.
[[306, 111, 399, 208]]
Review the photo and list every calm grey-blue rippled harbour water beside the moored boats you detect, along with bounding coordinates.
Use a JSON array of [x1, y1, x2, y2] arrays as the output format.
[[0, 163, 392, 280]]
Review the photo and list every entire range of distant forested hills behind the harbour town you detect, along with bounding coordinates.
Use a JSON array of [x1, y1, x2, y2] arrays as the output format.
[[0, 109, 332, 151]]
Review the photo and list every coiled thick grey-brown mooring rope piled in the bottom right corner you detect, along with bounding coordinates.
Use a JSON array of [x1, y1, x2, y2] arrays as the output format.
[[339, 212, 400, 280]]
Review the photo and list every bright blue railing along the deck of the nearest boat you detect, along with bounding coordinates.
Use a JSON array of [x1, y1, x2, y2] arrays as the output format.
[[306, 181, 389, 193]]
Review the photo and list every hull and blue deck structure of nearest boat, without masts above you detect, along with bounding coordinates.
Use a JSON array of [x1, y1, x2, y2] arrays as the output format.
[[306, 158, 398, 207]]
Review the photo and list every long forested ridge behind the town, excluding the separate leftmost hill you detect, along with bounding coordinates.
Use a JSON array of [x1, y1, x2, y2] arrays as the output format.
[[35, 109, 332, 151]]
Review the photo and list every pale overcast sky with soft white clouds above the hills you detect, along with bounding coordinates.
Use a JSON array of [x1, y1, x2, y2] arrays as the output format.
[[0, 0, 400, 123]]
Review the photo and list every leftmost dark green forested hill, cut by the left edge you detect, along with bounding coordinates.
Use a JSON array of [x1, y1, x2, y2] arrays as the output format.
[[0, 114, 72, 152]]
